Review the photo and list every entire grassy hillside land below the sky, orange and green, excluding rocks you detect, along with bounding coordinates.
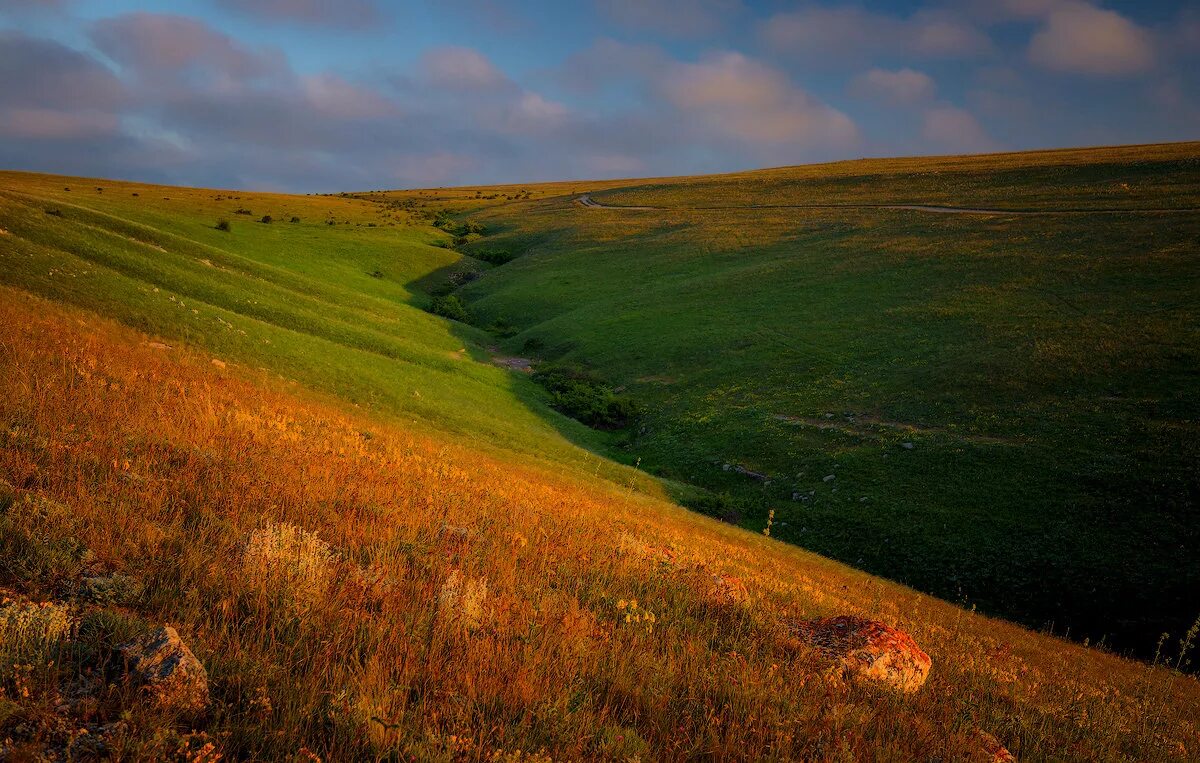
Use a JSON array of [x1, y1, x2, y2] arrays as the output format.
[[0, 146, 1200, 762]]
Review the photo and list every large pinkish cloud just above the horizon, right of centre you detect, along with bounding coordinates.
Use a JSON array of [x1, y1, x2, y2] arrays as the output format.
[[661, 53, 858, 149]]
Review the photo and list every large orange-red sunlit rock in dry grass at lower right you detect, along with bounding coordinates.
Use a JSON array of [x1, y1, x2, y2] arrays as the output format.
[[793, 614, 932, 692]]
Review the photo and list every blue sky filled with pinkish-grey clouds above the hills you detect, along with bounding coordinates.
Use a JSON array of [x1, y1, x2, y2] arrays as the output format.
[[0, 0, 1200, 192]]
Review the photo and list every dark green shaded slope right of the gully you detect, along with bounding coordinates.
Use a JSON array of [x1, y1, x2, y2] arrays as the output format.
[[408, 144, 1200, 651]]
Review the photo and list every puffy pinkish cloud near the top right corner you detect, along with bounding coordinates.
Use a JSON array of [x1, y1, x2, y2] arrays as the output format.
[[1028, 2, 1156, 76]]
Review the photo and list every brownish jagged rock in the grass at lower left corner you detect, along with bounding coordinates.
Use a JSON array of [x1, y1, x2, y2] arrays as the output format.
[[121, 625, 209, 711]]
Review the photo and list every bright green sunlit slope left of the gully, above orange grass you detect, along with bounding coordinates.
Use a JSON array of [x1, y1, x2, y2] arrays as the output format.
[[0, 173, 655, 489]]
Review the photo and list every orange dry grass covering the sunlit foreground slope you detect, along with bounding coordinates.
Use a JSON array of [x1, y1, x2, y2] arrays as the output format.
[[0, 283, 1200, 761]]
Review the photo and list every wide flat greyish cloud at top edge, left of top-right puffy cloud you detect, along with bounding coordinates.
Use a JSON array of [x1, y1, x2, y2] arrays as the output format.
[[762, 6, 992, 61]]
